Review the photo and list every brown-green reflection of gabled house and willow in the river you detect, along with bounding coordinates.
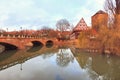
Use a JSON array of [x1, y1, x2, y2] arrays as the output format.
[[73, 48, 120, 80]]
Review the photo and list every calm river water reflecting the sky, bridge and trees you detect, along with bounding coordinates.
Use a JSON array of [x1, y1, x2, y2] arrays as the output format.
[[0, 46, 120, 80]]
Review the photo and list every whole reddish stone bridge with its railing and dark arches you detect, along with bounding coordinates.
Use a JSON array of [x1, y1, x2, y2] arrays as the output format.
[[0, 34, 57, 50]]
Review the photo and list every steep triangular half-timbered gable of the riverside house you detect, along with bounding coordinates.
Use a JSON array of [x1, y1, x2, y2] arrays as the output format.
[[73, 18, 89, 31]]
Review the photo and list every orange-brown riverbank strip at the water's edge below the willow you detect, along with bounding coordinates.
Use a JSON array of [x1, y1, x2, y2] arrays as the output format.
[[71, 39, 120, 56]]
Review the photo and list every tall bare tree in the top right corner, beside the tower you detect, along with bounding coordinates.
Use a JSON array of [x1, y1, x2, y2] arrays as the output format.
[[104, 0, 120, 28]]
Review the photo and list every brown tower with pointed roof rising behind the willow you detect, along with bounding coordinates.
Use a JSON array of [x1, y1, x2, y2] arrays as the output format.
[[91, 10, 108, 32]]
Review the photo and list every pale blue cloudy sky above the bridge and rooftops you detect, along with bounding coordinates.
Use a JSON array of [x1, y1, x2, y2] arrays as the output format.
[[0, 0, 104, 30]]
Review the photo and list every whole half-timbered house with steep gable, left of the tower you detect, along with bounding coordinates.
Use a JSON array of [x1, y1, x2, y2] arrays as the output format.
[[70, 18, 89, 39]]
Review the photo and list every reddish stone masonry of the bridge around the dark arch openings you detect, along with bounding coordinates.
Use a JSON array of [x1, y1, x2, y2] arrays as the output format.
[[0, 37, 57, 49]]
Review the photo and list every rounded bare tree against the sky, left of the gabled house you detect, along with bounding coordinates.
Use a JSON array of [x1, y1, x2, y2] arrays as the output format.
[[56, 19, 70, 32]]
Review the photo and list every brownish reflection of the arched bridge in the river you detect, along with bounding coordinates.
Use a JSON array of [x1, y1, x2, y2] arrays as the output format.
[[0, 46, 58, 70]]
